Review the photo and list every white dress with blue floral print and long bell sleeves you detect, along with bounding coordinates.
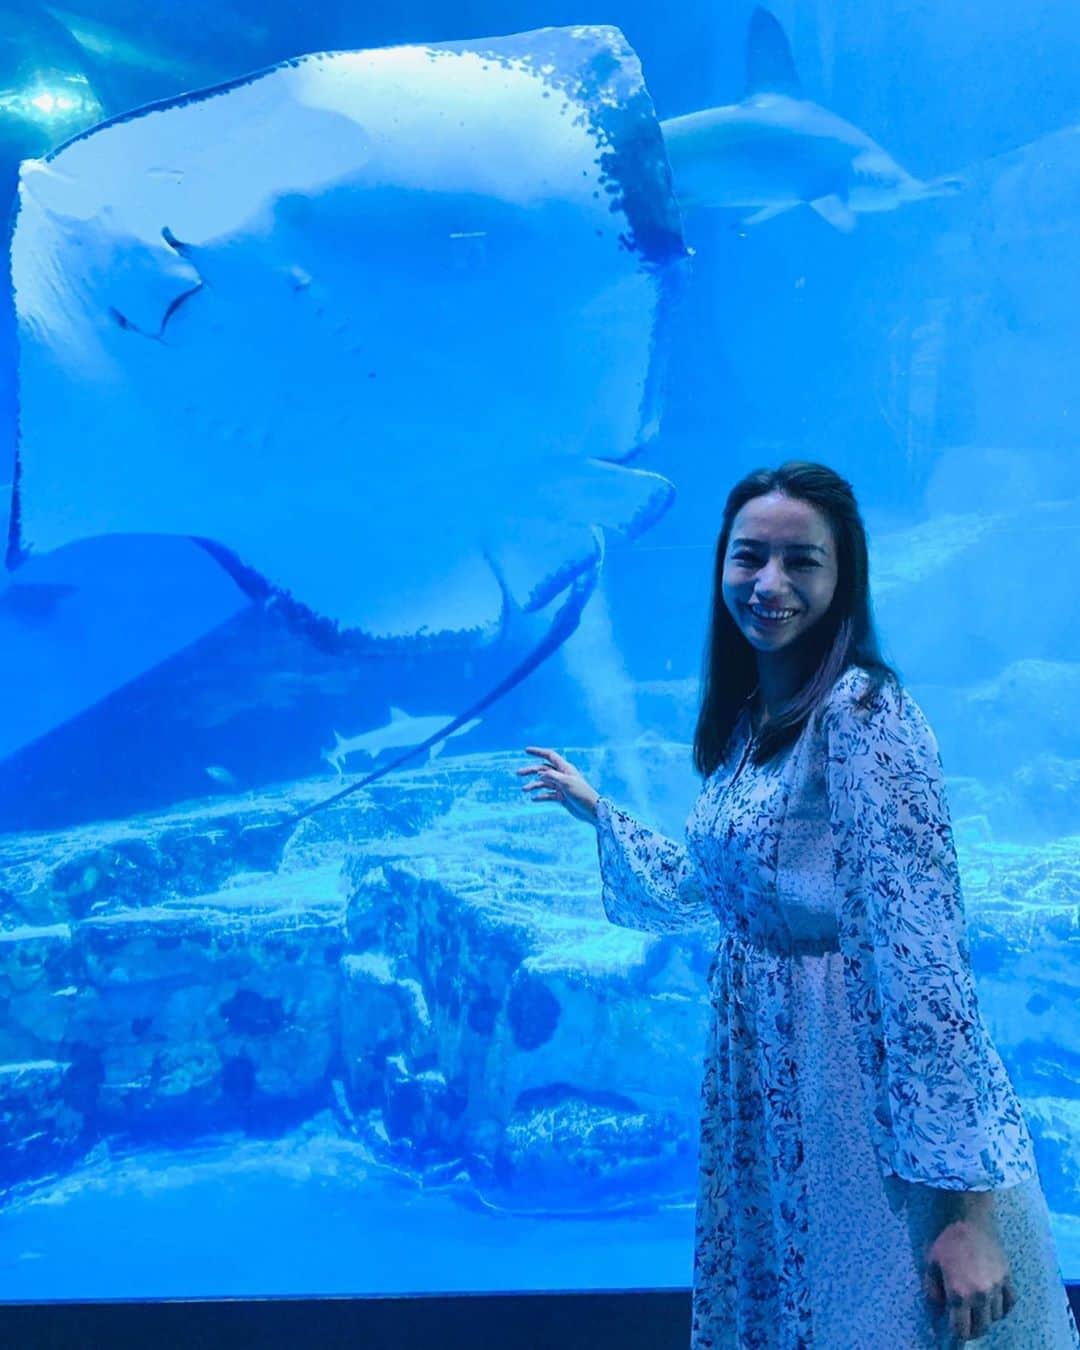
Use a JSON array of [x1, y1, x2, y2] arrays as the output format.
[[597, 667, 1080, 1350]]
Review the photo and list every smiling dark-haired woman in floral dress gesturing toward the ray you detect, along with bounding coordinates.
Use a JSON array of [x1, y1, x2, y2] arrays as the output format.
[[518, 462, 1080, 1350]]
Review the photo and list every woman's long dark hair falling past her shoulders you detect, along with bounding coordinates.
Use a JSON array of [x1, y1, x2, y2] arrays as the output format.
[[694, 459, 900, 776]]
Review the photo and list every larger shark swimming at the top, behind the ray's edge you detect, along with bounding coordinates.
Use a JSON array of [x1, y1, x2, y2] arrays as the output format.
[[660, 7, 965, 232]]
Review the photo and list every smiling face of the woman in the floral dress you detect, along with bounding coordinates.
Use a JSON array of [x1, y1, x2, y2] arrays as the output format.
[[724, 493, 837, 652]]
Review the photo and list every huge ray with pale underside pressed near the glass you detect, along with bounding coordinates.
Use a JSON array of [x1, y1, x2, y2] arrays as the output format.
[[0, 28, 686, 815]]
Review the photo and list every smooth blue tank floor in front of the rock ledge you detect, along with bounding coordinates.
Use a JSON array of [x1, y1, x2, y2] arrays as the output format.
[[0, 1141, 693, 1303]]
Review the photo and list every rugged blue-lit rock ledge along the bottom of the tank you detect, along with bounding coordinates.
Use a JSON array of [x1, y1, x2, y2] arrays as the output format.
[[0, 740, 1080, 1212]]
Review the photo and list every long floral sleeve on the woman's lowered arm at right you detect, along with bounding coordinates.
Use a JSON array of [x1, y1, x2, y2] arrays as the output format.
[[824, 676, 1035, 1191]]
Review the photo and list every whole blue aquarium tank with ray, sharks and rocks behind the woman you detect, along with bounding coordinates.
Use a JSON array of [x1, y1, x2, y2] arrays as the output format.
[[0, 0, 1080, 1301]]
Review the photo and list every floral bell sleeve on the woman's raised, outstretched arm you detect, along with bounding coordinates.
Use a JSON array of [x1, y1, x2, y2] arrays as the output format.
[[595, 797, 716, 933]]
